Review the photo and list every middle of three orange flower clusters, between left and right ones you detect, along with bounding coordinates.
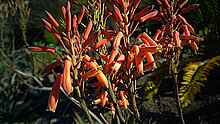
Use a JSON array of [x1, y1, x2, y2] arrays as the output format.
[[87, 0, 160, 109]]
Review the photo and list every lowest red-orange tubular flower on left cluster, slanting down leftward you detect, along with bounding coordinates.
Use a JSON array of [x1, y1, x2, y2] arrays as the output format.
[[48, 75, 63, 112]]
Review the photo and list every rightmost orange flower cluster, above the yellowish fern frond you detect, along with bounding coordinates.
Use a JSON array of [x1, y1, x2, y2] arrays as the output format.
[[153, 0, 201, 55]]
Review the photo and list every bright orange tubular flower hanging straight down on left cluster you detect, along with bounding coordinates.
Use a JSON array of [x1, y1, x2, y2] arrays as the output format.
[[62, 59, 73, 95]]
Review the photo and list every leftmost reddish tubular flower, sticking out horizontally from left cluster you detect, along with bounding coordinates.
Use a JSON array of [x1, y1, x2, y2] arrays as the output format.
[[28, 46, 56, 54]]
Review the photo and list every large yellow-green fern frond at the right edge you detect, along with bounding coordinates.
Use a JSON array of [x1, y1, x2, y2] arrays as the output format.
[[179, 56, 220, 107]]
